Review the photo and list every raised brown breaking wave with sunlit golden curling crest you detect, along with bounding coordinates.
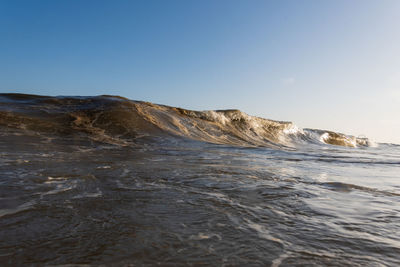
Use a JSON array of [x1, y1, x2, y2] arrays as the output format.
[[0, 94, 372, 148]]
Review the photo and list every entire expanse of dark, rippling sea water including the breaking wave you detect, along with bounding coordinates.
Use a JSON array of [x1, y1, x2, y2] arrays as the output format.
[[0, 94, 400, 266]]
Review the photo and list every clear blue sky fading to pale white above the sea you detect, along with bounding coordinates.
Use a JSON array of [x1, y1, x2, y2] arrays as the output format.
[[0, 0, 400, 144]]
